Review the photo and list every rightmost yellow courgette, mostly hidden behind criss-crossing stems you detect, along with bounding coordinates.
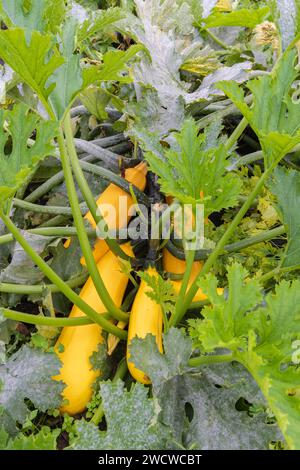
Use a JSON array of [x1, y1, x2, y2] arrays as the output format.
[[163, 248, 223, 302]]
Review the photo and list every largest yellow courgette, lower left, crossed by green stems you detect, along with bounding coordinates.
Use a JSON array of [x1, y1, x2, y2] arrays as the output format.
[[53, 243, 133, 415]]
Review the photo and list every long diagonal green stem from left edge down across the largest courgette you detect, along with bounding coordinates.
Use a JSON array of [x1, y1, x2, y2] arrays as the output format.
[[0, 210, 127, 339]]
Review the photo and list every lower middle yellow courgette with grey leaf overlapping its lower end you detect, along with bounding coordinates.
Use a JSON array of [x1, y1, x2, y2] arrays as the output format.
[[127, 268, 163, 384]]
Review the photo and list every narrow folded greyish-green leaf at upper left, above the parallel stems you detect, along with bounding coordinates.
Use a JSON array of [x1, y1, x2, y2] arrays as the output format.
[[49, 19, 83, 120]]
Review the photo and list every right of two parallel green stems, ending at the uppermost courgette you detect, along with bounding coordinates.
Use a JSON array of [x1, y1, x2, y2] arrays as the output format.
[[64, 115, 130, 260]]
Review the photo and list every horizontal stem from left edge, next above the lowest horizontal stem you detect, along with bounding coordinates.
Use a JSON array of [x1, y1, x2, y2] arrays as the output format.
[[0, 273, 88, 295]]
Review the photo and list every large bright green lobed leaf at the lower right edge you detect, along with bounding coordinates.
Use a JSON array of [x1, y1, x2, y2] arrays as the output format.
[[190, 264, 300, 449]]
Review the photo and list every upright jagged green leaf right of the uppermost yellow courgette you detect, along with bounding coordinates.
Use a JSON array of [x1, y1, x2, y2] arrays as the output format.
[[141, 119, 241, 216]]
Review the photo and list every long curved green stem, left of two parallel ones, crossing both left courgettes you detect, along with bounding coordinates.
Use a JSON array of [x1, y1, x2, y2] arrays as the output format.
[[58, 129, 128, 321]]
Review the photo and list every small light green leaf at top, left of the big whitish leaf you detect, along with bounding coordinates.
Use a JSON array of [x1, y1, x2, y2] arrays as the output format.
[[77, 7, 126, 44]]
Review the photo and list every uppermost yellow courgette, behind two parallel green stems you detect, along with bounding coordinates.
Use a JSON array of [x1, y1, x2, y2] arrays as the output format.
[[81, 162, 147, 266]]
